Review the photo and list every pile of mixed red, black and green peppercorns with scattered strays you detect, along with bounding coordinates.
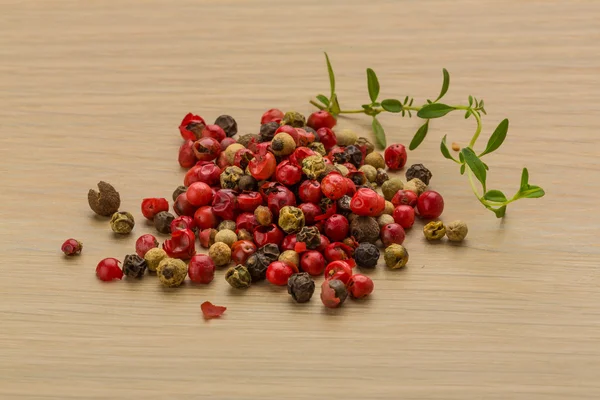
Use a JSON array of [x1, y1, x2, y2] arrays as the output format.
[[63, 109, 467, 308]]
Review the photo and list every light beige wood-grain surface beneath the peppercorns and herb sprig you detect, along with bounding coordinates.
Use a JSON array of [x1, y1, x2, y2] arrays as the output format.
[[0, 0, 600, 400]]
